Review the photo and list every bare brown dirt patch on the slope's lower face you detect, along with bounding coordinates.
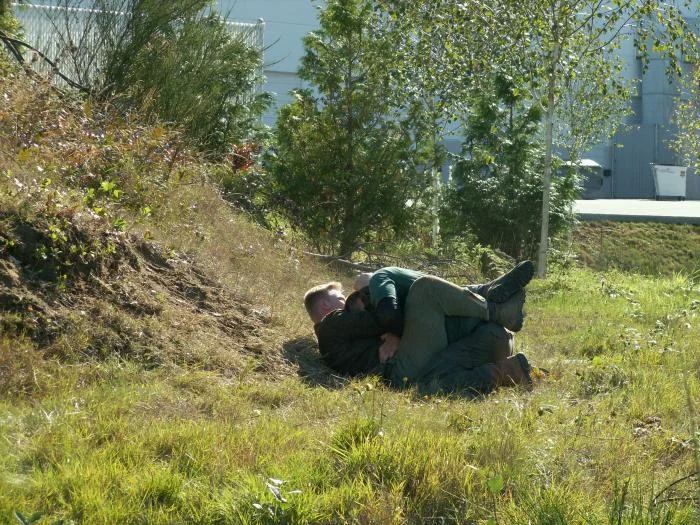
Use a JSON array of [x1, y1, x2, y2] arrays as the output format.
[[0, 217, 269, 372]]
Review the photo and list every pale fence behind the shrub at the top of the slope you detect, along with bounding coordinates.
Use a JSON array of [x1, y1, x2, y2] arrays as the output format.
[[11, 3, 265, 86]]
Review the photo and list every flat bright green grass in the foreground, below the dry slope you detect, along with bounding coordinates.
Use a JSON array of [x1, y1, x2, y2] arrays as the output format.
[[0, 270, 700, 524]]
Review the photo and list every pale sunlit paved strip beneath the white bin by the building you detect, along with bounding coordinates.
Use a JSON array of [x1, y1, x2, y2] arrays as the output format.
[[574, 199, 700, 224]]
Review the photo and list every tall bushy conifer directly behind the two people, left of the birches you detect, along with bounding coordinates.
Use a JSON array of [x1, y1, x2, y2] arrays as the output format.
[[271, 0, 429, 256]]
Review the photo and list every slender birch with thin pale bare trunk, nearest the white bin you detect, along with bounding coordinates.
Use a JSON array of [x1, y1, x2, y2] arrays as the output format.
[[502, 0, 696, 277]]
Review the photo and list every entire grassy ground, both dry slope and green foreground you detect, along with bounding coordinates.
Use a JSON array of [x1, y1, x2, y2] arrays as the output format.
[[0, 71, 700, 525]]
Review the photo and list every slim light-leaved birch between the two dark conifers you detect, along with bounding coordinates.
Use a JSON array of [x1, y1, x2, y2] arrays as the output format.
[[374, 0, 478, 239]]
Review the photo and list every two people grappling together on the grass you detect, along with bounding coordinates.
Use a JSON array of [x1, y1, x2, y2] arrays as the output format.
[[304, 261, 534, 394]]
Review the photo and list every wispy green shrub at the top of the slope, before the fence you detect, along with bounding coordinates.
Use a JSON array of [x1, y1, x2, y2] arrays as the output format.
[[58, 0, 270, 157]]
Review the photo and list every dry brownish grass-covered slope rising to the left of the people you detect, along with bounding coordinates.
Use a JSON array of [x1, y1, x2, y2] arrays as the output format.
[[0, 66, 340, 393]]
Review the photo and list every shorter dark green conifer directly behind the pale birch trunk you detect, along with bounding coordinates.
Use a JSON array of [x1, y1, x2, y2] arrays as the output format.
[[443, 77, 577, 259]]
